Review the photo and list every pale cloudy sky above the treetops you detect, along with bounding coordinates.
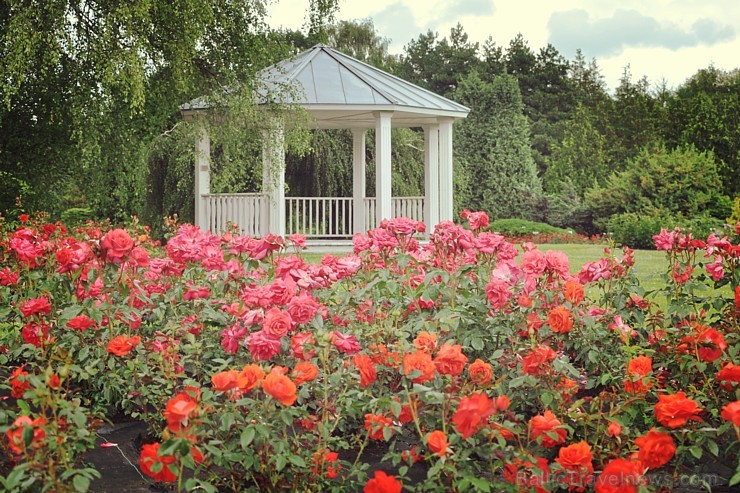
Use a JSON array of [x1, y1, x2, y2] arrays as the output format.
[[268, 0, 740, 91]]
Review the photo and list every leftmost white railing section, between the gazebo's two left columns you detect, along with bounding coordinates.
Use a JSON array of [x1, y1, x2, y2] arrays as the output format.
[[201, 193, 268, 236]]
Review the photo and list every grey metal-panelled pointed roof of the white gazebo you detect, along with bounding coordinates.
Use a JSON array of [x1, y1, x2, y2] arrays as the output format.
[[181, 44, 470, 128]]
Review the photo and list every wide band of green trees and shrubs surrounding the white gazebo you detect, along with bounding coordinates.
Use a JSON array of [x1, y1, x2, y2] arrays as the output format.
[[0, 4, 740, 242]]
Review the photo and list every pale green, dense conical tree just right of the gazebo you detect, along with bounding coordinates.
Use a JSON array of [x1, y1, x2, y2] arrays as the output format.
[[455, 72, 542, 219]]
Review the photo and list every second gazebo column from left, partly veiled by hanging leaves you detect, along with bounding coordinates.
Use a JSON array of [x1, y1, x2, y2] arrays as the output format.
[[261, 118, 285, 236]]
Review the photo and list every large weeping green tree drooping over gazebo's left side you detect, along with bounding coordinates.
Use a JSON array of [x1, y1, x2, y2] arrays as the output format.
[[0, 0, 337, 217]]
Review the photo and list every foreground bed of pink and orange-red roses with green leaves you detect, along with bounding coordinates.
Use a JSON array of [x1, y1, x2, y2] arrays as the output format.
[[0, 213, 740, 493]]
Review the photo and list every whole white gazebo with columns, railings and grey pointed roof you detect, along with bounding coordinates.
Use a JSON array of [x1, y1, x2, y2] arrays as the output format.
[[181, 45, 470, 239]]
